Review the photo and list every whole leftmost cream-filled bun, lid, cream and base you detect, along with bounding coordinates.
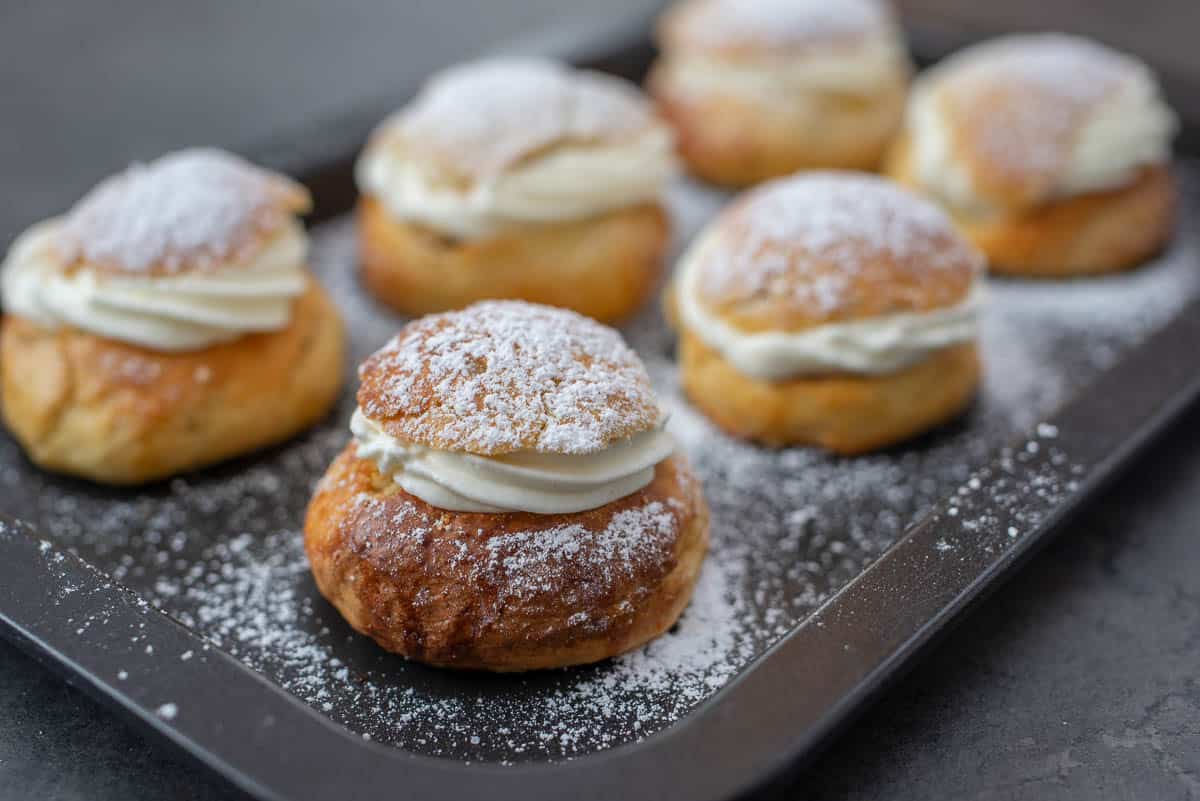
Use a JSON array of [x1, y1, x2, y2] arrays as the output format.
[[0, 150, 343, 483]]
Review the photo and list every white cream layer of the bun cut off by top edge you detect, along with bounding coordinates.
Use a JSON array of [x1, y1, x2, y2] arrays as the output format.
[[671, 30, 908, 103]]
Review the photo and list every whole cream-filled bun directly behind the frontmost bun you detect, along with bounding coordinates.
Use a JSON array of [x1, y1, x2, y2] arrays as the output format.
[[356, 60, 677, 320]]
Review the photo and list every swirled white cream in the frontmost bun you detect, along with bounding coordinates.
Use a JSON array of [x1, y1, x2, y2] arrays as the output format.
[[350, 409, 676, 514]]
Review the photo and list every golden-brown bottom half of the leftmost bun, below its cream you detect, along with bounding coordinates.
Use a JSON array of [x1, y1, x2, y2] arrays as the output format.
[[0, 282, 344, 484]]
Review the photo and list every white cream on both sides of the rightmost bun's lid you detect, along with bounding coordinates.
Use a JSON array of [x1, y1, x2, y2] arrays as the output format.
[[908, 70, 1178, 211]]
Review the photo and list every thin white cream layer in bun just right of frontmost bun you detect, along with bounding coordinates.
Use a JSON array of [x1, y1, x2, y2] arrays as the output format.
[[677, 231, 984, 381]]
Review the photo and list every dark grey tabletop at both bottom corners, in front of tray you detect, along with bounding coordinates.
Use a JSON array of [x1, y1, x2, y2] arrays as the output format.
[[7, 412, 1200, 801]]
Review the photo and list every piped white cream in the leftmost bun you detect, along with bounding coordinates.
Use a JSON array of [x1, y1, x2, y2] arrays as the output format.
[[0, 219, 308, 351]]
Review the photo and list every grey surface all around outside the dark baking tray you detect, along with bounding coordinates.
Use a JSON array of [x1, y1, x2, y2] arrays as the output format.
[[0, 0, 1200, 801]]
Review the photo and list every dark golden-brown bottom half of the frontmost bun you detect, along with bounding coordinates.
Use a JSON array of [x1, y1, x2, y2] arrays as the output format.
[[305, 445, 708, 671]]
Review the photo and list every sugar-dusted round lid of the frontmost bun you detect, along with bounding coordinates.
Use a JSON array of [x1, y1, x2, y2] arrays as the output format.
[[358, 301, 661, 456]]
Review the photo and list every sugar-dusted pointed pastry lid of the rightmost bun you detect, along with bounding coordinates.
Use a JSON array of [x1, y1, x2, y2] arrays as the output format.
[[920, 34, 1158, 204]]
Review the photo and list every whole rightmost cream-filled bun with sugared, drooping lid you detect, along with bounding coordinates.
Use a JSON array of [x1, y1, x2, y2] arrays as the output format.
[[888, 34, 1177, 276]]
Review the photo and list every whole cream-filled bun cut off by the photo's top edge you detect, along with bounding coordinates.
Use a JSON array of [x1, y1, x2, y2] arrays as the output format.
[[649, 0, 911, 186]]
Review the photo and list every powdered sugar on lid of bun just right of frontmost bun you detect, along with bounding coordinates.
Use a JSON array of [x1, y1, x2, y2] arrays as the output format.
[[700, 173, 982, 313]]
